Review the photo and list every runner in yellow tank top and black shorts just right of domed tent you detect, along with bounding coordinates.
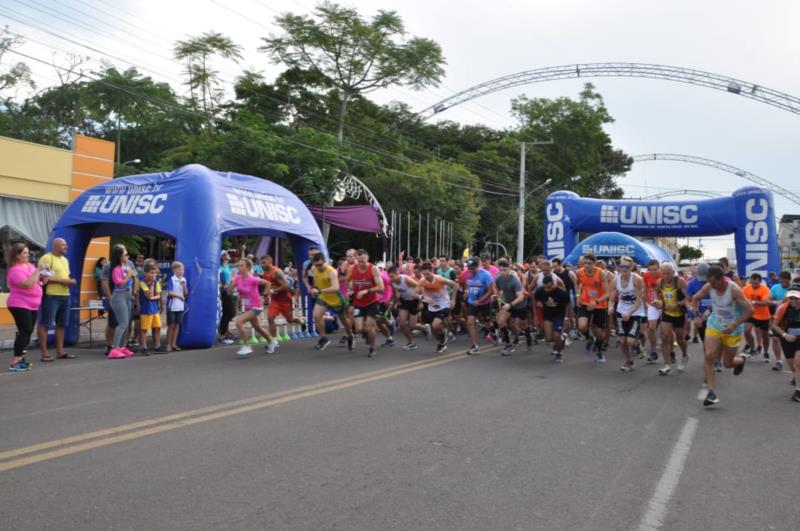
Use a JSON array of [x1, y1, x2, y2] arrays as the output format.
[[310, 253, 353, 350]]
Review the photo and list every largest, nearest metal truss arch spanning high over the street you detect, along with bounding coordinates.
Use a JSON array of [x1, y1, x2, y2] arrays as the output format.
[[419, 63, 800, 119]]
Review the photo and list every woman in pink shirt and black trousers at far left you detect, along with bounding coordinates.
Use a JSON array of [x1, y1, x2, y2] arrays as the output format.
[[7, 243, 44, 372]]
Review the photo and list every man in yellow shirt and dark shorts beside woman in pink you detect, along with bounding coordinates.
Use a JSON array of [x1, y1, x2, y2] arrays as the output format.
[[38, 238, 77, 361]]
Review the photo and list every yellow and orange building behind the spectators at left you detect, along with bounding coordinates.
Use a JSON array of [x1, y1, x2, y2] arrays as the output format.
[[0, 135, 114, 324]]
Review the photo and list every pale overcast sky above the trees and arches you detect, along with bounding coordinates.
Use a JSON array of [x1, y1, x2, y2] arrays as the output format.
[[0, 0, 800, 256]]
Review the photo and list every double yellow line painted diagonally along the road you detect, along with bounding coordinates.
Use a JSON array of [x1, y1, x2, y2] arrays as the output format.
[[0, 351, 482, 472]]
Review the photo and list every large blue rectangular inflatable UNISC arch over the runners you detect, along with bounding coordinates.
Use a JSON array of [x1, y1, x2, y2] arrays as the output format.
[[544, 186, 781, 277]]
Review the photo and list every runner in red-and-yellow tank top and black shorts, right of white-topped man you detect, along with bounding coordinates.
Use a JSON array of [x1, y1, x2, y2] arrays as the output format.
[[656, 262, 689, 376]]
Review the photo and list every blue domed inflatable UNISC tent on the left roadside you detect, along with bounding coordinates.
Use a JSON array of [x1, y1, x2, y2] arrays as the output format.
[[48, 164, 327, 348]]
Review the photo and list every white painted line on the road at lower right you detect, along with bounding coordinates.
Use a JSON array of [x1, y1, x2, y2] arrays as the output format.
[[639, 417, 698, 531]]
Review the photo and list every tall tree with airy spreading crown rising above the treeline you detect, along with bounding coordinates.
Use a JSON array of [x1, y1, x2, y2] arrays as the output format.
[[266, 2, 445, 141]]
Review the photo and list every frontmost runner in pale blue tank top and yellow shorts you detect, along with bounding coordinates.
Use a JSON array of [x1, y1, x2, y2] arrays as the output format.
[[691, 266, 753, 407]]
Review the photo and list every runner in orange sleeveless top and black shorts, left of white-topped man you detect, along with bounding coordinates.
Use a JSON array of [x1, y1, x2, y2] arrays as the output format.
[[577, 254, 608, 363]]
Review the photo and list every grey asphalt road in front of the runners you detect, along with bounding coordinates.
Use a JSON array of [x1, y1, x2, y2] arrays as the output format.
[[0, 338, 800, 531]]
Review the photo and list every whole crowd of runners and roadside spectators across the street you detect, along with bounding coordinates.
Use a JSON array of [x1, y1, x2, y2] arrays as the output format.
[[9, 240, 800, 406]]
